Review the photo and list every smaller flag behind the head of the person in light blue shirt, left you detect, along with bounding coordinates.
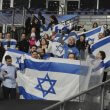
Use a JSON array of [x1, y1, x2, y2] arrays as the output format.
[[2, 49, 29, 68]]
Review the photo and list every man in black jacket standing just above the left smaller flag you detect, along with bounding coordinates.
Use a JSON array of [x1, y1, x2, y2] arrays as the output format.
[[17, 33, 29, 53]]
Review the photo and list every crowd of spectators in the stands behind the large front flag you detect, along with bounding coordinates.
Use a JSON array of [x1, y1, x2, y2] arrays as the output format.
[[0, 12, 110, 99]]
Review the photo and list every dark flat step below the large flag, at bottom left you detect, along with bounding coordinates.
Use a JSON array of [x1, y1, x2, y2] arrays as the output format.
[[0, 100, 59, 110]]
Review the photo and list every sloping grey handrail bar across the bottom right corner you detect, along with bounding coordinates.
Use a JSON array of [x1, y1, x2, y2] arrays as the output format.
[[43, 80, 110, 110]]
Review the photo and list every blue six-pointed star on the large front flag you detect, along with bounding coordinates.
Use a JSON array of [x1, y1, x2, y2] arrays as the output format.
[[35, 73, 56, 97]]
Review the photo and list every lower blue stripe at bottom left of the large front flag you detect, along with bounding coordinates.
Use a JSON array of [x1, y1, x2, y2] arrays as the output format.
[[19, 86, 44, 100]]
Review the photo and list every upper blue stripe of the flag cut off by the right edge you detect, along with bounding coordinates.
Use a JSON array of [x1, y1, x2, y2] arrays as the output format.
[[91, 37, 110, 52]]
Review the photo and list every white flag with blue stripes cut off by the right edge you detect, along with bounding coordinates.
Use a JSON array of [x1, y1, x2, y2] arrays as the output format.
[[91, 36, 110, 69]]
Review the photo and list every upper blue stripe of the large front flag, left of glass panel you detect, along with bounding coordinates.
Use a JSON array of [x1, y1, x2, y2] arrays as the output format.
[[20, 59, 81, 74]]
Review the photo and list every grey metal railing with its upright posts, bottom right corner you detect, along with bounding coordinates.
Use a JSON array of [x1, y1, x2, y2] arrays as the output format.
[[43, 80, 110, 110]]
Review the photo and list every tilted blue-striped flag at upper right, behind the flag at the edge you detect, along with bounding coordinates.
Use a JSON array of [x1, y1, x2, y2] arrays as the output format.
[[78, 26, 104, 42]]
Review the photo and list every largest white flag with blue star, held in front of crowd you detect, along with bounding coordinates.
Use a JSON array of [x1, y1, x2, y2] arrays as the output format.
[[17, 55, 81, 101]]
